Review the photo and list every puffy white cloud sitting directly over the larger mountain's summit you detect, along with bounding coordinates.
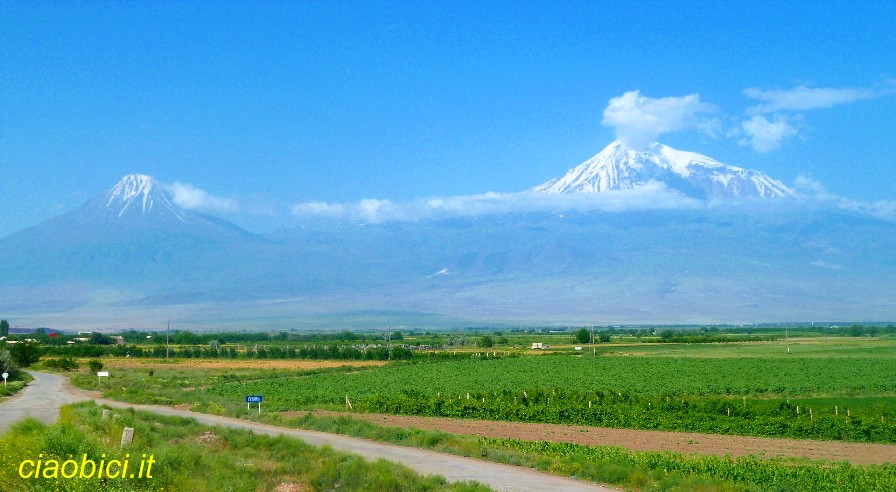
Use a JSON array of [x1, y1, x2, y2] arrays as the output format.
[[602, 91, 718, 148]]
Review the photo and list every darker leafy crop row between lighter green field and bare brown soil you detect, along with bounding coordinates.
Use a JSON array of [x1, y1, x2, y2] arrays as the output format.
[[364, 389, 896, 443]]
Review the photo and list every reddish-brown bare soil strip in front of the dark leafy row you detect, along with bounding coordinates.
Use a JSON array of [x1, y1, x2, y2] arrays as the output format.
[[296, 410, 896, 465]]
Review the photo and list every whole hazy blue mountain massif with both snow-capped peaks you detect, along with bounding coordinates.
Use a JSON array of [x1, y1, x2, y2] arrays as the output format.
[[0, 171, 896, 329]]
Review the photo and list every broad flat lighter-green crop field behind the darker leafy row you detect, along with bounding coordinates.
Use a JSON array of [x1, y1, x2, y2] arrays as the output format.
[[211, 356, 896, 410]]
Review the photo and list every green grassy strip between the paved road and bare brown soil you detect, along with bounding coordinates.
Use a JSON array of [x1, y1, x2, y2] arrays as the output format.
[[263, 413, 896, 492]]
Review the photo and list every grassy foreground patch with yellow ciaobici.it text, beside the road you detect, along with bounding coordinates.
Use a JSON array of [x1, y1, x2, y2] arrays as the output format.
[[0, 403, 488, 492]]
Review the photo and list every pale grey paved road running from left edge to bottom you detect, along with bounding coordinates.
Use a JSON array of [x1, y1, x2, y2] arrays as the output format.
[[0, 372, 615, 492]]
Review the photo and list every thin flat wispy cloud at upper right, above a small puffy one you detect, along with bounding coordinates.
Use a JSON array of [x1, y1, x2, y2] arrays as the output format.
[[744, 86, 885, 115]]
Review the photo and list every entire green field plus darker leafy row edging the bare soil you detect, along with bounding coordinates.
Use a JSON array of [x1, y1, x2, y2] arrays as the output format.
[[203, 356, 896, 442]]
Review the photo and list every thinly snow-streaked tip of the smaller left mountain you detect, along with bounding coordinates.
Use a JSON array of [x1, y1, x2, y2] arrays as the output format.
[[104, 174, 187, 221]]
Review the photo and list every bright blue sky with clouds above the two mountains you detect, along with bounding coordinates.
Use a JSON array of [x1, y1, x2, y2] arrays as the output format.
[[0, 1, 896, 236]]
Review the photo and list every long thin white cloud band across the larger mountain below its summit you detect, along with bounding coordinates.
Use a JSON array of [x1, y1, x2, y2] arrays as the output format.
[[292, 182, 706, 223]]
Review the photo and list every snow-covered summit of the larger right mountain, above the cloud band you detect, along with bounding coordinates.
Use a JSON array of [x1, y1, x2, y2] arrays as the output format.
[[531, 141, 793, 198]]
